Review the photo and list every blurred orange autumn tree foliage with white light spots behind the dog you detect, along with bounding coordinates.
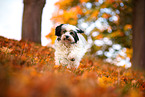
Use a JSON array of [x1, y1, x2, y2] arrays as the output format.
[[47, 0, 132, 63]]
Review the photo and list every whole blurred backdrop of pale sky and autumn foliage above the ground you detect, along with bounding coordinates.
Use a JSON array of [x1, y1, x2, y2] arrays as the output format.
[[0, 0, 133, 68]]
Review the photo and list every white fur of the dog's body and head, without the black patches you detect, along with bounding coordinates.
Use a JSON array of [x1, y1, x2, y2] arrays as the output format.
[[55, 24, 89, 68]]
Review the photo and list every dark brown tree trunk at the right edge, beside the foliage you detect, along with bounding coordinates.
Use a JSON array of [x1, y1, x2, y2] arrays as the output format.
[[132, 0, 145, 70]]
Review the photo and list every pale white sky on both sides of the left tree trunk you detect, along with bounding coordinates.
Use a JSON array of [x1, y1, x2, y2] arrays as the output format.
[[0, 0, 57, 46]]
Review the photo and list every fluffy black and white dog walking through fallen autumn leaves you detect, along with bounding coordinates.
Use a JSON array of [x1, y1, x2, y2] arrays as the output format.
[[55, 24, 89, 68]]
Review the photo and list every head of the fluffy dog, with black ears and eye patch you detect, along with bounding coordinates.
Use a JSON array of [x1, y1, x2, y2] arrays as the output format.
[[55, 24, 84, 44]]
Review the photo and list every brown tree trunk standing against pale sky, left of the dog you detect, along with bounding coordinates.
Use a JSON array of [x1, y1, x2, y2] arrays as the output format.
[[22, 0, 46, 44]]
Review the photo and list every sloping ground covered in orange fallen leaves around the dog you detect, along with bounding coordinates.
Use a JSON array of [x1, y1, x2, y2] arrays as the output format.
[[0, 37, 145, 97]]
